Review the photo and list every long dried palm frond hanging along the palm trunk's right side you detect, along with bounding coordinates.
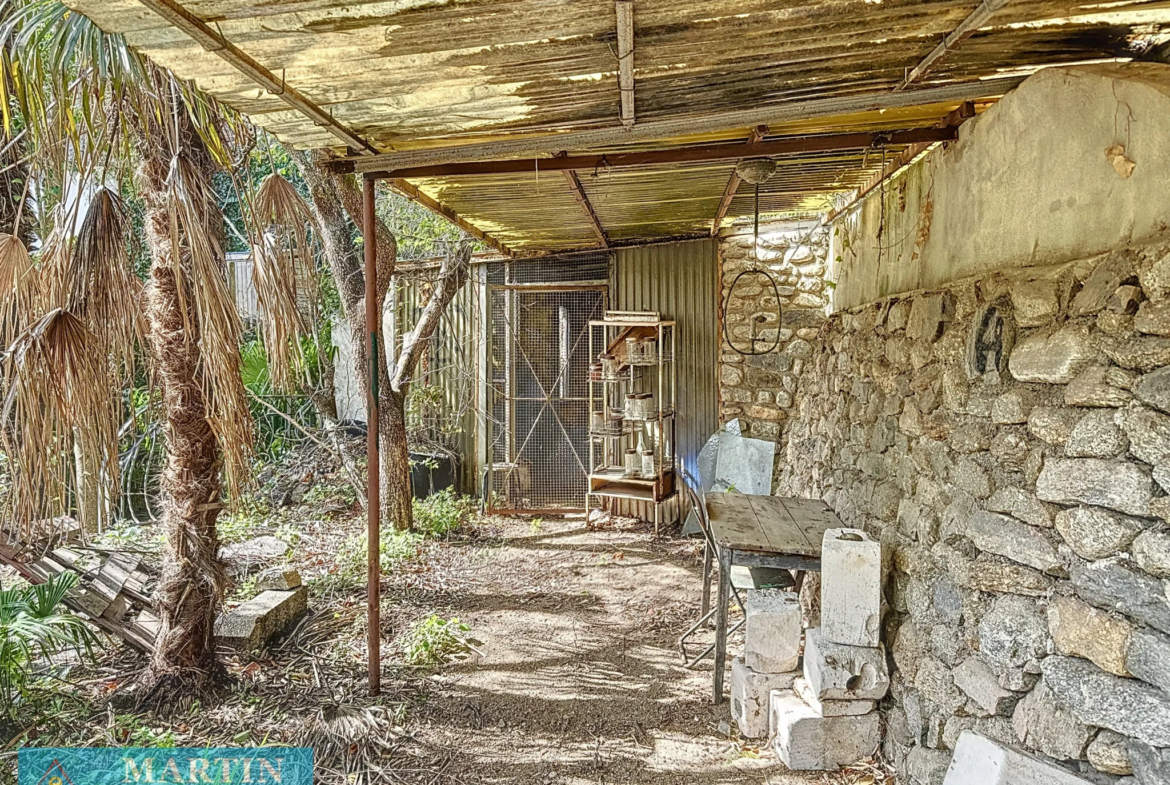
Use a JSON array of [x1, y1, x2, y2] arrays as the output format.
[[166, 156, 252, 496]]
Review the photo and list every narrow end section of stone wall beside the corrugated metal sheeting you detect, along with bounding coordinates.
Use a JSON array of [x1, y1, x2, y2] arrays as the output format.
[[718, 223, 828, 441]]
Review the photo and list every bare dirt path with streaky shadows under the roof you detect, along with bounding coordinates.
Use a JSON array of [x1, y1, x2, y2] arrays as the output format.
[[383, 518, 828, 785]]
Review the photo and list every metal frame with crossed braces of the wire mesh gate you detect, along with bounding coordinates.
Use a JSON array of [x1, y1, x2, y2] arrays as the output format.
[[484, 281, 610, 515]]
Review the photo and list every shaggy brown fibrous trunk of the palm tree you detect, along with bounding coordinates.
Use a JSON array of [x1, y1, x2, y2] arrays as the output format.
[[138, 112, 225, 702]]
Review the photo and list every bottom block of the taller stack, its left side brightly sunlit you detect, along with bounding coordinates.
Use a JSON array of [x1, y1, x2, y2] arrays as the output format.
[[771, 690, 881, 771]]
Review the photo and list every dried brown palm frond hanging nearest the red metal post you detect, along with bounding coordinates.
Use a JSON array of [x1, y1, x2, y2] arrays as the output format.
[[252, 172, 318, 390]]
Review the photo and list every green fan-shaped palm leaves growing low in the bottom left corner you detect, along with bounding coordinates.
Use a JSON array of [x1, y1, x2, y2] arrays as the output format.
[[0, 572, 94, 719]]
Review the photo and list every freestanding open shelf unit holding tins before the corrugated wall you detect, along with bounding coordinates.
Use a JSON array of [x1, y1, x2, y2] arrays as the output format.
[[585, 311, 677, 531]]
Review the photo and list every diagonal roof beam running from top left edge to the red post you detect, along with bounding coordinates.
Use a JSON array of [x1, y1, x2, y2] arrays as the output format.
[[138, 0, 379, 154]]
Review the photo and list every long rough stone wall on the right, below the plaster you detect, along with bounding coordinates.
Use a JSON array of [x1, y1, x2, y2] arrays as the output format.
[[776, 243, 1170, 785]]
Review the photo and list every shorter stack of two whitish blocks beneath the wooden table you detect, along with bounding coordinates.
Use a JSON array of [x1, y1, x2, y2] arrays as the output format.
[[731, 588, 800, 738]]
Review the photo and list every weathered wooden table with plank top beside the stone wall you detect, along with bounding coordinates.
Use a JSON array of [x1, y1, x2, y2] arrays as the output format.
[[707, 494, 844, 703]]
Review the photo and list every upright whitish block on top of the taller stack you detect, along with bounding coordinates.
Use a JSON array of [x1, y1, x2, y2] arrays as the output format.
[[820, 529, 881, 646]]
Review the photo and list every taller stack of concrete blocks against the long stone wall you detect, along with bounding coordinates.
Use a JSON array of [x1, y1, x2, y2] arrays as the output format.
[[770, 529, 889, 771]]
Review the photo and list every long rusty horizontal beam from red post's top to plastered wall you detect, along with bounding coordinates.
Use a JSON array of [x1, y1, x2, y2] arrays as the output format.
[[366, 128, 955, 179]]
